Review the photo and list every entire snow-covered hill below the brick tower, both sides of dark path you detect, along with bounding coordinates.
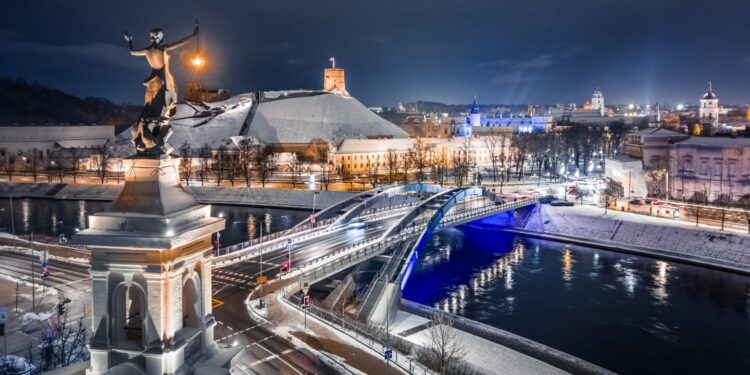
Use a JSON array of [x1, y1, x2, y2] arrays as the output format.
[[118, 90, 408, 150]]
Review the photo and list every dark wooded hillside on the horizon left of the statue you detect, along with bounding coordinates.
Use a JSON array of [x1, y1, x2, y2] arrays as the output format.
[[0, 79, 140, 132]]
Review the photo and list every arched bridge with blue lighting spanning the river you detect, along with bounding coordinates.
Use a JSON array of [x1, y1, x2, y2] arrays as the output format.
[[214, 184, 537, 324]]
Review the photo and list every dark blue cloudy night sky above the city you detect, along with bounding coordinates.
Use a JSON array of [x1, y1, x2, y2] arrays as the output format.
[[0, 0, 750, 105]]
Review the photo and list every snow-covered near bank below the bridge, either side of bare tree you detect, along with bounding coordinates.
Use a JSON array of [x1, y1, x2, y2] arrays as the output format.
[[391, 311, 566, 375]]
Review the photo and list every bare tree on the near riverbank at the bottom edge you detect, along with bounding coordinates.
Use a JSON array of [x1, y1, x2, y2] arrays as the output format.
[[420, 311, 467, 374]]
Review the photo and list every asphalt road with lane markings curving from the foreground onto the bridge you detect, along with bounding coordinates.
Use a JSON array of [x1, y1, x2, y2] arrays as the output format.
[[212, 217, 398, 374]]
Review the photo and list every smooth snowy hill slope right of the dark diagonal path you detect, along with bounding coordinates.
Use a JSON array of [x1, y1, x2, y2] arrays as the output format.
[[248, 93, 408, 144]]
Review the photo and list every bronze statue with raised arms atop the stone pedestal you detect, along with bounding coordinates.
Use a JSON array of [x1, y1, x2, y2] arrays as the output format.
[[124, 20, 199, 155]]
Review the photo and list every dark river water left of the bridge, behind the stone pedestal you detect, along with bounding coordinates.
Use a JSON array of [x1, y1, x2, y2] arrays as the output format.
[[0, 198, 310, 246]]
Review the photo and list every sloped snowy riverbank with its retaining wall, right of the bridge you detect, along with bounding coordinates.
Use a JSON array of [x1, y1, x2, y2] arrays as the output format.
[[507, 205, 750, 275]]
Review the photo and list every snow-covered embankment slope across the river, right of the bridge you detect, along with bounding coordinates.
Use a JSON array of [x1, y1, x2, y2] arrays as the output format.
[[520, 205, 750, 270]]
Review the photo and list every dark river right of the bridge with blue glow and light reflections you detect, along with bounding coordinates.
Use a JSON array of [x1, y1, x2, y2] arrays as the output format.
[[404, 223, 750, 374]]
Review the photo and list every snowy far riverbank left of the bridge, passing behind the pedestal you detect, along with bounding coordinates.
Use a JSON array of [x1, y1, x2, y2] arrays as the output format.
[[0, 182, 354, 210]]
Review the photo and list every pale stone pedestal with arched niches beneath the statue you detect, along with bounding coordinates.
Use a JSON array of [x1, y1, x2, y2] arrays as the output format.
[[73, 156, 229, 374]]
